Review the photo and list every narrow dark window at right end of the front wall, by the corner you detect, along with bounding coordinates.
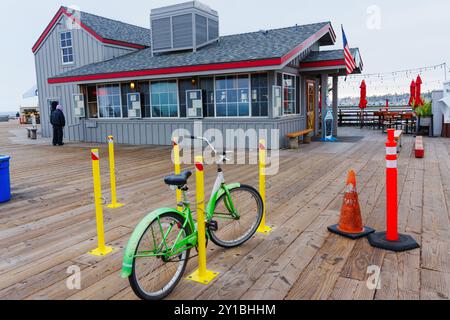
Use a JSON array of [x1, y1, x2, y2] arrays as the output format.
[[251, 73, 269, 117]]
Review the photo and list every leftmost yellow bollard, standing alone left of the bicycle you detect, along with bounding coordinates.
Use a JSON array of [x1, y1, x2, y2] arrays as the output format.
[[89, 149, 113, 257]]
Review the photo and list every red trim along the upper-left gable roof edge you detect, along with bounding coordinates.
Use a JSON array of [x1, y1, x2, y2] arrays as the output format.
[[32, 7, 147, 53]]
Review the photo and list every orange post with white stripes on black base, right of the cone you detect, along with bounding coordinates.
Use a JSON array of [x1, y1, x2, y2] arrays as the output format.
[[368, 129, 420, 252]]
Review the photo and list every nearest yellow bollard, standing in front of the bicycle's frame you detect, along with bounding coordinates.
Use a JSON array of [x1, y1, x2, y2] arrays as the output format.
[[187, 157, 219, 285]]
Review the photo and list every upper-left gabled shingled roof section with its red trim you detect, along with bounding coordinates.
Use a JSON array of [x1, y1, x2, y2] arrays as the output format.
[[33, 7, 151, 53]]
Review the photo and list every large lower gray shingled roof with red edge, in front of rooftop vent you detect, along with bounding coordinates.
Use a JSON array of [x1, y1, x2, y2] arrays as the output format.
[[49, 22, 334, 83]]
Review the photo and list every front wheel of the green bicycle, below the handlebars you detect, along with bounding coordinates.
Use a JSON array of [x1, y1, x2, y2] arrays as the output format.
[[209, 185, 264, 248]]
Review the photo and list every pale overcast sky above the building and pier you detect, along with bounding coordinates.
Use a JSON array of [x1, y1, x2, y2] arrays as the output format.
[[0, 0, 450, 112]]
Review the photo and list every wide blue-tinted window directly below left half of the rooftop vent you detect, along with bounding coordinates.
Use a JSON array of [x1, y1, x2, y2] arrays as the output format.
[[151, 80, 178, 118]]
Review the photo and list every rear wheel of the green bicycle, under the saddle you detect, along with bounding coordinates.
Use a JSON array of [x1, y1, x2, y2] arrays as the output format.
[[129, 213, 191, 300]]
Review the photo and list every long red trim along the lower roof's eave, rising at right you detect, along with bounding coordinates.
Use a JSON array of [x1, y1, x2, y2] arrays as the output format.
[[48, 24, 331, 84]]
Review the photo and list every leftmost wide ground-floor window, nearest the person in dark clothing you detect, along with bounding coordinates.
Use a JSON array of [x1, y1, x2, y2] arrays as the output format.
[[97, 84, 122, 118]]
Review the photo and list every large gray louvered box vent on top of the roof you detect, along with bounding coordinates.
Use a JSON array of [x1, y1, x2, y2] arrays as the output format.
[[150, 1, 219, 53]]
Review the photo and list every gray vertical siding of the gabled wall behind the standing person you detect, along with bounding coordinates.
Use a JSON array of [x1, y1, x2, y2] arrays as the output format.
[[35, 17, 135, 140]]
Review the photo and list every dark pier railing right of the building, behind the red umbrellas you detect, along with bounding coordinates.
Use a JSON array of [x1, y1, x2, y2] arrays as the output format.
[[338, 106, 412, 127]]
